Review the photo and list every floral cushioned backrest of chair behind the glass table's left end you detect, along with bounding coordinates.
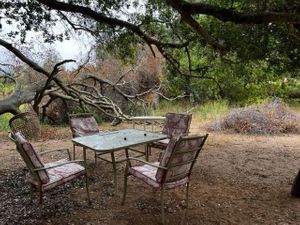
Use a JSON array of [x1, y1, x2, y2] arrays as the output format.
[[69, 113, 99, 137]]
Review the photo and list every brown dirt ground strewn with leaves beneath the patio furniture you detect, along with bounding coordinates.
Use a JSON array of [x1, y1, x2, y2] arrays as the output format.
[[0, 124, 300, 225]]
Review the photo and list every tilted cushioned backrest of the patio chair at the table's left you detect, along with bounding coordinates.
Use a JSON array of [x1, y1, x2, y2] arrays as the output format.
[[10, 132, 49, 184]]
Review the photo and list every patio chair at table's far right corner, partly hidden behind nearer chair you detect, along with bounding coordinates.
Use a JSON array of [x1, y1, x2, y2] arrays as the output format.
[[148, 113, 192, 154]]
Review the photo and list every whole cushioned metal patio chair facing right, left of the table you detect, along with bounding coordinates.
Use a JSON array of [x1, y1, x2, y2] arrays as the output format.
[[9, 132, 90, 204]]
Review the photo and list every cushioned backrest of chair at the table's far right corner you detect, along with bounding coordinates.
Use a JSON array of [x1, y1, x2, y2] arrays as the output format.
[[162, 113, 192, 137]]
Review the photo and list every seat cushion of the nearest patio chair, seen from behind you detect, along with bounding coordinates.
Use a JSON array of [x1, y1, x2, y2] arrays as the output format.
[[128, 162, 188, 188]]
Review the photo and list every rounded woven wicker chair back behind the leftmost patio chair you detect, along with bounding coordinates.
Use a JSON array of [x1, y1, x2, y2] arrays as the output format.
[[9, 111, 41, 140]]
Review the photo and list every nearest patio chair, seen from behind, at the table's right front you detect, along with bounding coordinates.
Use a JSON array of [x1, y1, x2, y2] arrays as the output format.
[[122, 134, 208, 224]]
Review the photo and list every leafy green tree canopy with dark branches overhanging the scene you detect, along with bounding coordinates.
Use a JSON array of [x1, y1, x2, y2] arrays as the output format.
[[0, 0, 300, 104]]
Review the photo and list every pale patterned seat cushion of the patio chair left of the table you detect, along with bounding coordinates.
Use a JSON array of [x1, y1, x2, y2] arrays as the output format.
[[31, 159, 85, 191]]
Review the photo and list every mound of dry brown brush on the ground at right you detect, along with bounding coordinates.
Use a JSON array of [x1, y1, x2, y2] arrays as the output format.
[[208, 98, 300, 135]]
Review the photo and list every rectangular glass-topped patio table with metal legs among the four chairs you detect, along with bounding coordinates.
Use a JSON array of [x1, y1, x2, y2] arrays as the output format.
[[72, 129, 167, 191]]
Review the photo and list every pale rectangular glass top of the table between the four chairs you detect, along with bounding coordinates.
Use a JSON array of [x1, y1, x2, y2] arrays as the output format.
[[72, 129, 167, 151]]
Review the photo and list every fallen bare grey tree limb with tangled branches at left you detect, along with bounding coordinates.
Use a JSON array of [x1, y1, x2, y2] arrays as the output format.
[[0, 39, 164, 120]]
